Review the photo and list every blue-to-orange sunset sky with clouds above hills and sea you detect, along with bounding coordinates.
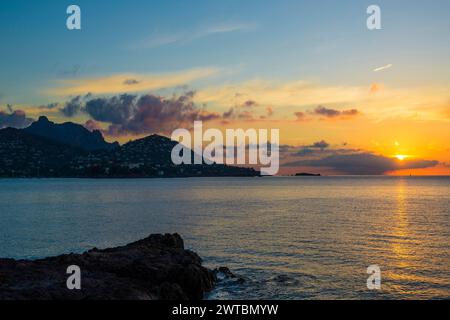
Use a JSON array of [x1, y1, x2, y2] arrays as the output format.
[[0, 0, 450, 175]]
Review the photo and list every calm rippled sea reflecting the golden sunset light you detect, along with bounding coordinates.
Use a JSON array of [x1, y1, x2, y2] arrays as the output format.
[[0, 177, 450, 299]]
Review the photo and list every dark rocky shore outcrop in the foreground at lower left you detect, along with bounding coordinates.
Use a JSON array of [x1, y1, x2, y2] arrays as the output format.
[[0, 234, 216, 300]]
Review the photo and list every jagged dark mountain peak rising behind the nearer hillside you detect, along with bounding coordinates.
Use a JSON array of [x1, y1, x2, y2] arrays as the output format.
[[24, 117, 119, 151]]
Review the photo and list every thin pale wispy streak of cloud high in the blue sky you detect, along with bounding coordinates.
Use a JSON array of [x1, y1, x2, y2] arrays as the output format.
[[132, 22, 256, 49]]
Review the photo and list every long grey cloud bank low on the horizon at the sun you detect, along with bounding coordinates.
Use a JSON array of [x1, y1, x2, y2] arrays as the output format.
[[288, 152, 439, 175]]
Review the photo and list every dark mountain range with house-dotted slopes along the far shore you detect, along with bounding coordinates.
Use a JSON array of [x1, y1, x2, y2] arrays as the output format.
[[0, 117, 259, 178]]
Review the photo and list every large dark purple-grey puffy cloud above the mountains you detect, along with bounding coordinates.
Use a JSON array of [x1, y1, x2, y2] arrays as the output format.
[[66, 91, 222, 137]]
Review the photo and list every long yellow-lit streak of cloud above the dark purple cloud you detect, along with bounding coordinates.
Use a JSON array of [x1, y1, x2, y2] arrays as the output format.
[[45, 68, 219, 96]]
